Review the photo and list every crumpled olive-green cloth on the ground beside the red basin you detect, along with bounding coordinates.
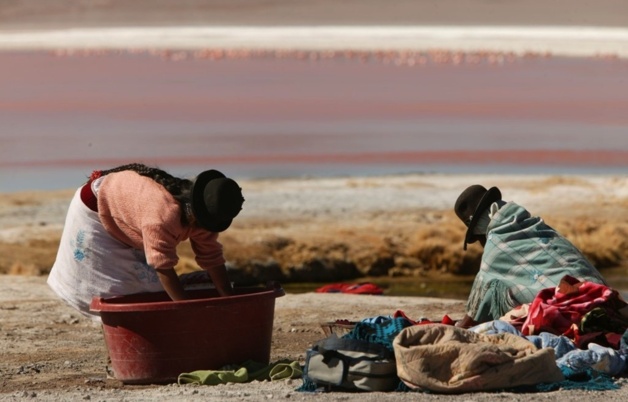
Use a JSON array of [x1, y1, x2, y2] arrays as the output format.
[[178, 360, 303, 385]]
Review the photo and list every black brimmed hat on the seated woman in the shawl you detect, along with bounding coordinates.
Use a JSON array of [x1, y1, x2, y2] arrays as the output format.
[[454, 184, 502, 250]]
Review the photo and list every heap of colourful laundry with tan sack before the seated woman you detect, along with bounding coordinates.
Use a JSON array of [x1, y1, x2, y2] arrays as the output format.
[[299, 276, 628, 393]]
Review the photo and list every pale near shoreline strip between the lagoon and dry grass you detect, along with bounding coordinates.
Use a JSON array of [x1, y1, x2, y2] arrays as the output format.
[[0, 174, 628, 242]]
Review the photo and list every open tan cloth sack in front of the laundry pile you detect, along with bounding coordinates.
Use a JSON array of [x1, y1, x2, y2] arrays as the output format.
[[393, 324, 564, 393]]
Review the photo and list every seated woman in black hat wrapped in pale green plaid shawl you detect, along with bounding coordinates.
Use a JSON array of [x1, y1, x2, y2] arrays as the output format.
[[454, 184, 606, 327]]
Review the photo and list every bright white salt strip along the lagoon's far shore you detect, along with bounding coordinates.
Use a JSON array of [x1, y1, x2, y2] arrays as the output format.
[[0, 26, 628, 59]]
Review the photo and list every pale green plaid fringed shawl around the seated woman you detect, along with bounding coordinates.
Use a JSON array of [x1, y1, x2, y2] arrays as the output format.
[[467, 202, 606, 322]]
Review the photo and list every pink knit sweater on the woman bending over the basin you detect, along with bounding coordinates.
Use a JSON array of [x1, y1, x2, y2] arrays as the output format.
[[98, 171, 225, 269]]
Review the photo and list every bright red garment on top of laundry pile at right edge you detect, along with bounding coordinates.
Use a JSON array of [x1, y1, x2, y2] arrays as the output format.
[[521, 275, 627, 342]]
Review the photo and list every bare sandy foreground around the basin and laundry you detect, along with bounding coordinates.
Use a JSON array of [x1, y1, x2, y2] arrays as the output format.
[[0, 276, 628, 402]]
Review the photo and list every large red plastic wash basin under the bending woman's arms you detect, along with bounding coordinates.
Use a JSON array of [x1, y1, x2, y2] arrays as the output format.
[[90, 284, 285, 384]]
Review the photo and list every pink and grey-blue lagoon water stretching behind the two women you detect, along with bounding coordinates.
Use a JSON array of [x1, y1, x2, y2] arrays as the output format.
[[0, 52, 628, 191]]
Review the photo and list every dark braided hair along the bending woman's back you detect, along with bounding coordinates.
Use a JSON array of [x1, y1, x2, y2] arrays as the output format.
[[89, 163, 193, 225]]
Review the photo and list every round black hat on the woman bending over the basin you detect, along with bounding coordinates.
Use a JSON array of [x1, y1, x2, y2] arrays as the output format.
[[192, 170, 244, 232]]
